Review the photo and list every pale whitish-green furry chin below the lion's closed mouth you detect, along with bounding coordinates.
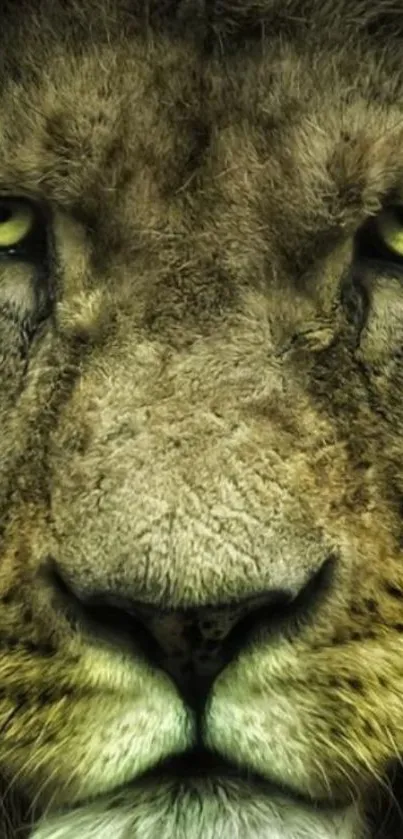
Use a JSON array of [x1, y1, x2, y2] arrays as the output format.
[[30, 772, 367, 839]]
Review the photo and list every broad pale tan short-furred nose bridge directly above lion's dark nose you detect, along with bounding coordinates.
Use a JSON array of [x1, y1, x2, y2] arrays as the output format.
[[49, 308, 327, 612]]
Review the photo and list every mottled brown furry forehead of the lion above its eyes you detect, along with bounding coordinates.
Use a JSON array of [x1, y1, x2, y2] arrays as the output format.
[[0, 0, 403, 316]]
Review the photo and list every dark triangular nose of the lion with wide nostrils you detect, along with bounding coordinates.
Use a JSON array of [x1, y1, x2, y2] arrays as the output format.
[[52, 557, 334, 709]]
